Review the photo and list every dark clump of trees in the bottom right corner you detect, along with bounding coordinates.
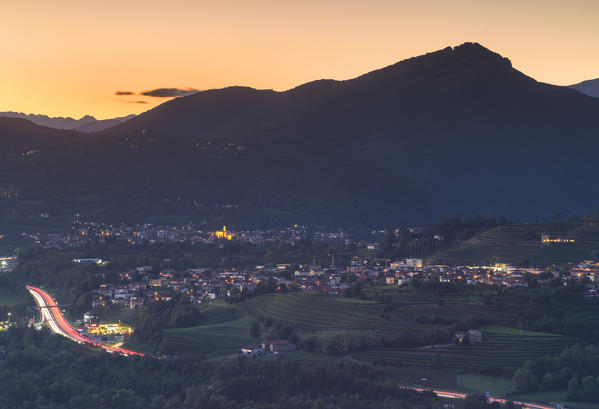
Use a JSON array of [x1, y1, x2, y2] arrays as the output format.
[[513, 345, 599, 401]]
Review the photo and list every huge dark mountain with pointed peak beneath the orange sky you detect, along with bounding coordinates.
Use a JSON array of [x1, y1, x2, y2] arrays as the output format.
[[0, 43, 599, 226]]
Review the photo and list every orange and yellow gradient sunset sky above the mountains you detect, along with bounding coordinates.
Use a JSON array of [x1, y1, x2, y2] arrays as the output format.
[[0, 0, 599, 118]]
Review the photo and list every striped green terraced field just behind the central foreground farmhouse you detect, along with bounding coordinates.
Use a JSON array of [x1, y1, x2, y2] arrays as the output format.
[[159, 293, 387, 356]]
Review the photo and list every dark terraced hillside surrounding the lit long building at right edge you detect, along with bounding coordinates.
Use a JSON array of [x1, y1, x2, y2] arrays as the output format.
[[429, 217, 599, 265]]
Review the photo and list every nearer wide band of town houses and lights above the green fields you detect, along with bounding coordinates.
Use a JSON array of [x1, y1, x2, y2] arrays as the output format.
[[85, 256, 599, 309]]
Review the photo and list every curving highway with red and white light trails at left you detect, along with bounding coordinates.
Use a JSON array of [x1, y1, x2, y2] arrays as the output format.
[[27, 285, 144, 356]]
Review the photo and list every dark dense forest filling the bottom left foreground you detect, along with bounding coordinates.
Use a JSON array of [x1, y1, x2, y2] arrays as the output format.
[[0, 328, 524, 409]]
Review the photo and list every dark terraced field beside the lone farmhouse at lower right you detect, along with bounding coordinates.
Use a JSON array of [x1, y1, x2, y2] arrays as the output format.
[[353, 327, 576, 369]]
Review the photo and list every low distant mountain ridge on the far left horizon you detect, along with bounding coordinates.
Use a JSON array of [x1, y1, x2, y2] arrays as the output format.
[[0, 111, 135, 132]]
